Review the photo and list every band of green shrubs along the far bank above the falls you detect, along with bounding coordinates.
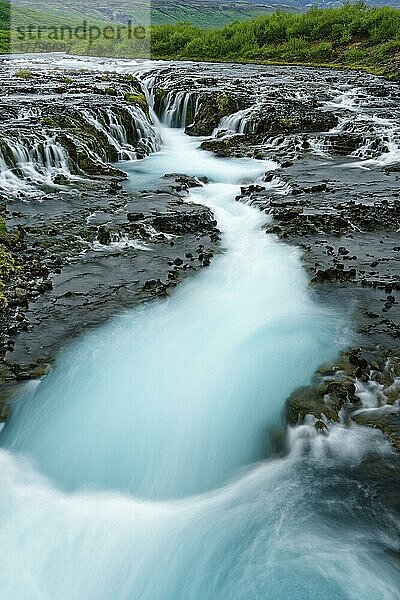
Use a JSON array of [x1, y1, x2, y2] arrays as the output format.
[[0, 2, 400, 79]]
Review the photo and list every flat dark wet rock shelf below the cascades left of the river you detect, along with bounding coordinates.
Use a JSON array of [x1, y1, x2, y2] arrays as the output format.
[[0, 175, 219, 392]]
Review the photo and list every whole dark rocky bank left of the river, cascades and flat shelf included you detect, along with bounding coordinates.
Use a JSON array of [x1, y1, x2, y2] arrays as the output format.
[[0, 62, 219, 420]]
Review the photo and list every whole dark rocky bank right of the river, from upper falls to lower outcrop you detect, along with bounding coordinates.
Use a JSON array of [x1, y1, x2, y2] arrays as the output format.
[[148, 61, 400, 450]]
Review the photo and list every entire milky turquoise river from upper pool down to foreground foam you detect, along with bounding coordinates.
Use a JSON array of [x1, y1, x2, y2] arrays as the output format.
[[0, 62, 400, 600]]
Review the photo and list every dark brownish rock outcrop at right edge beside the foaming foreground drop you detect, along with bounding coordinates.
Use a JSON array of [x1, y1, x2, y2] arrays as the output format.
[[287, 348, 400, 452]]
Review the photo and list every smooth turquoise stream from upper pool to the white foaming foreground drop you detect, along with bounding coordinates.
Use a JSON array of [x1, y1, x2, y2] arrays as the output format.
[[1, 130, 342, 498]]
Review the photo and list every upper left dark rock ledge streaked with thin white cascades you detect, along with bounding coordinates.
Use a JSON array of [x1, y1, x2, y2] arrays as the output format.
[[0, 68, 160, 194]]
